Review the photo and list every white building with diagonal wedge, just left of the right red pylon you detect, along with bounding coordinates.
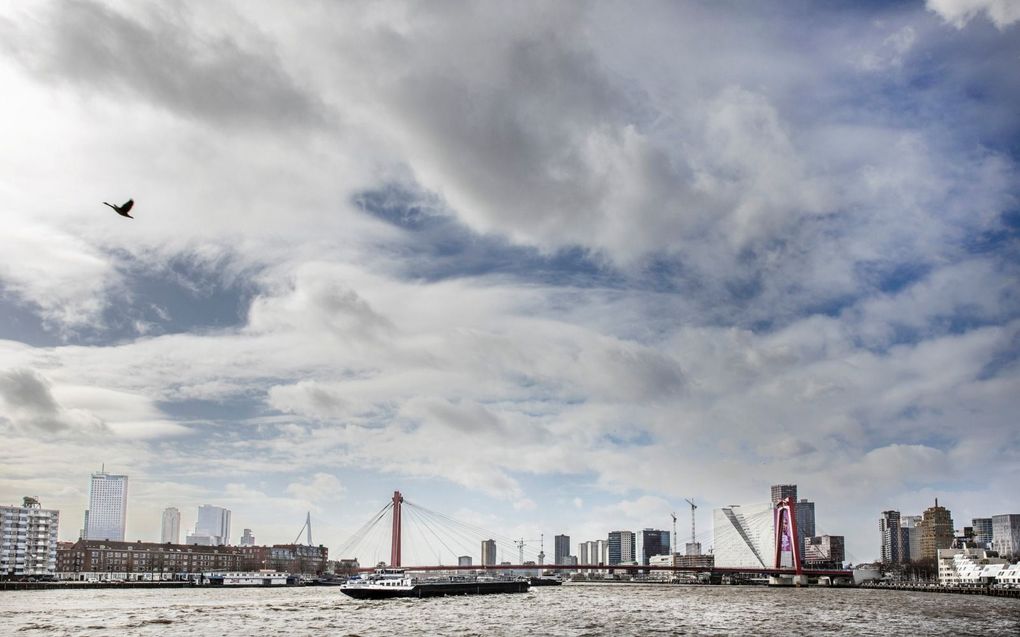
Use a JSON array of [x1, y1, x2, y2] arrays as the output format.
[[712, 503, 775, 569]]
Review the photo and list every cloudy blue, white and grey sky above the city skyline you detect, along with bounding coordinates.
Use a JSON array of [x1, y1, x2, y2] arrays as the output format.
[[0, 0, 1020, 562]]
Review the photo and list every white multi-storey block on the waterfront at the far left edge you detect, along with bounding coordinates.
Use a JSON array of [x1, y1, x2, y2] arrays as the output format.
[[0, 497, 60, 577]]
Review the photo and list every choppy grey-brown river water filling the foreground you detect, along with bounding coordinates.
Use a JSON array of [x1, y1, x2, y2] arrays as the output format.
[[0, 584, 1020, 637]]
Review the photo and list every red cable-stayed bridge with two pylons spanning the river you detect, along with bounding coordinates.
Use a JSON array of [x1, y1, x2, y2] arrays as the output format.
[[339, 491, 853, 585]]
